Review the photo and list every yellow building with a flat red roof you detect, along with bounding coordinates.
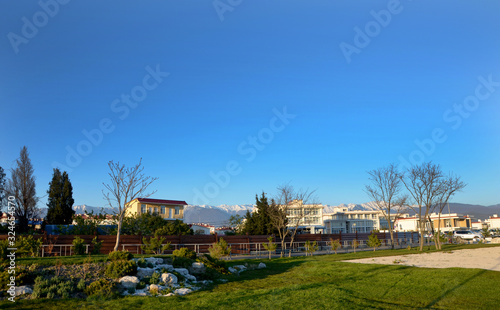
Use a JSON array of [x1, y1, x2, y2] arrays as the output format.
[[126, 198, 187, 221]]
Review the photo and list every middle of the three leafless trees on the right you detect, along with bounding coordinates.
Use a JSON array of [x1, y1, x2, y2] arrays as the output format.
[[401, 162, 454, 251]]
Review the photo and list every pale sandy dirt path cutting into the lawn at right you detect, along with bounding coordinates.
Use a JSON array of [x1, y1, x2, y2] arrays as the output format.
[[345, 247, 500, 271]]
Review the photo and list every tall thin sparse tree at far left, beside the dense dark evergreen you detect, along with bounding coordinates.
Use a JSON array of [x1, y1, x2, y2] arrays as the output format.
[[7, 146, 40, 232]]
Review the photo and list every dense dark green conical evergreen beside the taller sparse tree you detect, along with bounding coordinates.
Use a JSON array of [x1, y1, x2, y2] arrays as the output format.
[[46, 168, 75, 225]]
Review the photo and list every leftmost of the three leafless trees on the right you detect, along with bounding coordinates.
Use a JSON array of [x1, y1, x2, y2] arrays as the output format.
[[365, 164, 407, 249]]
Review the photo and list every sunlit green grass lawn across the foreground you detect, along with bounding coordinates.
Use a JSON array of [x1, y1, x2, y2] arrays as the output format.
[[0, 245, 500, 310]]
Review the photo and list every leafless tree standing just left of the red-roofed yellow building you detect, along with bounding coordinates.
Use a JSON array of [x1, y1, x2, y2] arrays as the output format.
[[102, 158, 158, 251]]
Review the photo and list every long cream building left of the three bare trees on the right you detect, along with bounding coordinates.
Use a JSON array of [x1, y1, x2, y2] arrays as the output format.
[[323, 207, 380, 234]]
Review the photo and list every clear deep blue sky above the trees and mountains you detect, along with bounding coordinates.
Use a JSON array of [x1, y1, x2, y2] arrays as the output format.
[[0, 0, 500, 206]]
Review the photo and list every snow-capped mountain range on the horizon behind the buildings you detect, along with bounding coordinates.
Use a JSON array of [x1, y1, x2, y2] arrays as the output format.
[[37, 202, 500, 226]]
